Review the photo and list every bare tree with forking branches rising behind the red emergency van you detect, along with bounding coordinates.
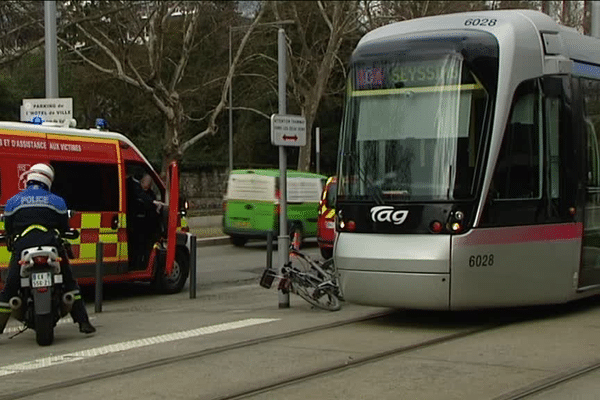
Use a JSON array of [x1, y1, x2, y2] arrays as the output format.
[[59, 1, 263, 172]]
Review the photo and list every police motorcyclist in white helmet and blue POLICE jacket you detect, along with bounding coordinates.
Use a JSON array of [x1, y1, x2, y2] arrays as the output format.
[[0, 164, 96, 333]]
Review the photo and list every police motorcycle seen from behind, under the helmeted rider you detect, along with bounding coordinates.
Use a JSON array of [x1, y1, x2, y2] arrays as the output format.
[[0, 219, 79, 346]]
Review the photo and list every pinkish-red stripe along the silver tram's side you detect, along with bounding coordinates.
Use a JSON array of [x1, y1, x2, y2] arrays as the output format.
[[454, 222, 583, 246]]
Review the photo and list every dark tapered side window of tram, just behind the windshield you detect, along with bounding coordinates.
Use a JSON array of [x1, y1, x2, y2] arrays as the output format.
[[492, 82, 542, 200]]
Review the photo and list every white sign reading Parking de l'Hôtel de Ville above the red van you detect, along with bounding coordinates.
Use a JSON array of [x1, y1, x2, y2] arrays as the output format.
[[21, 98, 73, 126]]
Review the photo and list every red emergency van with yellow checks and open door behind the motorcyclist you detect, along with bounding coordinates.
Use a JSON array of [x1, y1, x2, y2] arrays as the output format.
[[0, 122, 191, 293]]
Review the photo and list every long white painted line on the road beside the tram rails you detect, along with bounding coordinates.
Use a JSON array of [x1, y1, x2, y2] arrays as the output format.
[[0, 318, 279, 376]]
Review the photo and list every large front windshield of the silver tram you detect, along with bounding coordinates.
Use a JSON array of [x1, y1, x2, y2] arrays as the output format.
[[339, 46, 491, 203]]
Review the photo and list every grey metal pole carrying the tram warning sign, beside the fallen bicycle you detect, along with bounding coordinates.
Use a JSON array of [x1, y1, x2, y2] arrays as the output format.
[[277, 28, 290, 308]]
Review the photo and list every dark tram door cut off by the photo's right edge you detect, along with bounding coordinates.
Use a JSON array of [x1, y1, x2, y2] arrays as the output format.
[[579, 79, 600, 288]]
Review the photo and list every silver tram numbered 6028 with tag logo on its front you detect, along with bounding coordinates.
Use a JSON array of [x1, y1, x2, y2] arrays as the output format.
[[334, 10, 600, 310]]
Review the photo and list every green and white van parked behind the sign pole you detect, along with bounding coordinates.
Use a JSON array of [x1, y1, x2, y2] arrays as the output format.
[[223, 169, 327, 246]]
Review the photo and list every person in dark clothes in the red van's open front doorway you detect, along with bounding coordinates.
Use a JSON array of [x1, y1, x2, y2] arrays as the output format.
[[127, 173, 165, 270]]
